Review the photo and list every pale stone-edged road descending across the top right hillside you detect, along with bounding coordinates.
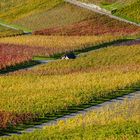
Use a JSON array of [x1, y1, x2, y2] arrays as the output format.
[[65, 0, 140, 27]]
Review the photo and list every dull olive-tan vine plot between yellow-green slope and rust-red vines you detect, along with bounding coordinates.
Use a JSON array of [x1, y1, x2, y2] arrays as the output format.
[[14, 3, 96, 30]]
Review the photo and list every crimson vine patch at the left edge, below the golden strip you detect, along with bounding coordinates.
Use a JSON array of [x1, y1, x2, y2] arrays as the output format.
[[0, 44, 58, 69]]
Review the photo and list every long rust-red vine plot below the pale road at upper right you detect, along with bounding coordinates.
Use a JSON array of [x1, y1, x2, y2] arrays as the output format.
[[34, 15, 140, 36]]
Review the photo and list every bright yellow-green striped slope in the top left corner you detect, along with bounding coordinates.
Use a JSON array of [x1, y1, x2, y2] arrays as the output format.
[[0, 0, 63, 22]]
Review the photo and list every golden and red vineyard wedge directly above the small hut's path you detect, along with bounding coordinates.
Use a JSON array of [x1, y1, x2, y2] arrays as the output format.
[[0, 36, 122, 72]]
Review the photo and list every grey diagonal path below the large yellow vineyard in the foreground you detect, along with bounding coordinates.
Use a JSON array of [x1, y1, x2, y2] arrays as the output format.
[[0, 91, 140, 138]]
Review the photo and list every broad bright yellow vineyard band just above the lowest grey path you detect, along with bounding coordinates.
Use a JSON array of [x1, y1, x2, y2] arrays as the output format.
[[0, 71, 140, 129]]
